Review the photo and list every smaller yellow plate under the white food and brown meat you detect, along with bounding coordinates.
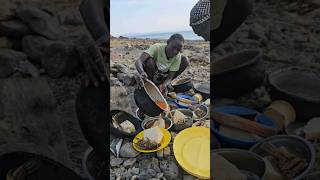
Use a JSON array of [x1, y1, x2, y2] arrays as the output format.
[[133, 128, 171, 153]]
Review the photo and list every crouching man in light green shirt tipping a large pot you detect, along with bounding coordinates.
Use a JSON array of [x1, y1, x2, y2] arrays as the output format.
[[135, 34, 189, 96]]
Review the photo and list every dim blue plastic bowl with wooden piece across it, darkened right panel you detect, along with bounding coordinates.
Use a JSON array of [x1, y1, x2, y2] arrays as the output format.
[[212, 106, 276, 149]]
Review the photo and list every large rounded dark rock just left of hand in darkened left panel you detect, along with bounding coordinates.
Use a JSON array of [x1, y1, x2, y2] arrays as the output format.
[[41, 42, 80, 78]]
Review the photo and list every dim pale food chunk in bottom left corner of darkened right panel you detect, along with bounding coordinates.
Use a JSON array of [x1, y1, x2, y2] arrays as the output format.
[[213, 153, 247, 180]]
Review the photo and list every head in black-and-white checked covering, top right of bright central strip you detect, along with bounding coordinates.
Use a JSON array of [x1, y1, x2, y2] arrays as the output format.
[[190, 0, 211, 41]]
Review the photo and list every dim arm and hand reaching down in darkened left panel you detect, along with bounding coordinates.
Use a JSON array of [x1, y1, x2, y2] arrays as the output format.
[[78, 0, 110, 86]]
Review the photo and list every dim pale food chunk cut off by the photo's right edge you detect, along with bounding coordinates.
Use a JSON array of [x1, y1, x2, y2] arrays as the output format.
[[303, 117, 320, 140]]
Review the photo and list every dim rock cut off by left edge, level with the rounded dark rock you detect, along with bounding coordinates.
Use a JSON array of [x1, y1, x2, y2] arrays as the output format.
[[0, 48, 27, 78]]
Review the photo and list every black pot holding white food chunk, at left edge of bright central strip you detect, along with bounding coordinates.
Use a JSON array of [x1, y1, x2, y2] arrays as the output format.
[[109, 110, 142, 138]]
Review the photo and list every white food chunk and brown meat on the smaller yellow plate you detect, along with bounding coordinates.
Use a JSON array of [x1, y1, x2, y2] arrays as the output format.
[[135, 127, 163, 150]]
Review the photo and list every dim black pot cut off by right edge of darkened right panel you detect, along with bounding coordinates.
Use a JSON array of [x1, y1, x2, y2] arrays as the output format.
[[268, 67, 320, 122]]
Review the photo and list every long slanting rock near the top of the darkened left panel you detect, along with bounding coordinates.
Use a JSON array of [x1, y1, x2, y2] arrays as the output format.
[[16, 7, 63, 40]]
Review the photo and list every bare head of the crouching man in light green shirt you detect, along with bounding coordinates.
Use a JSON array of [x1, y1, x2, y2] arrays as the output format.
[[166, 34, 184, 58]]
